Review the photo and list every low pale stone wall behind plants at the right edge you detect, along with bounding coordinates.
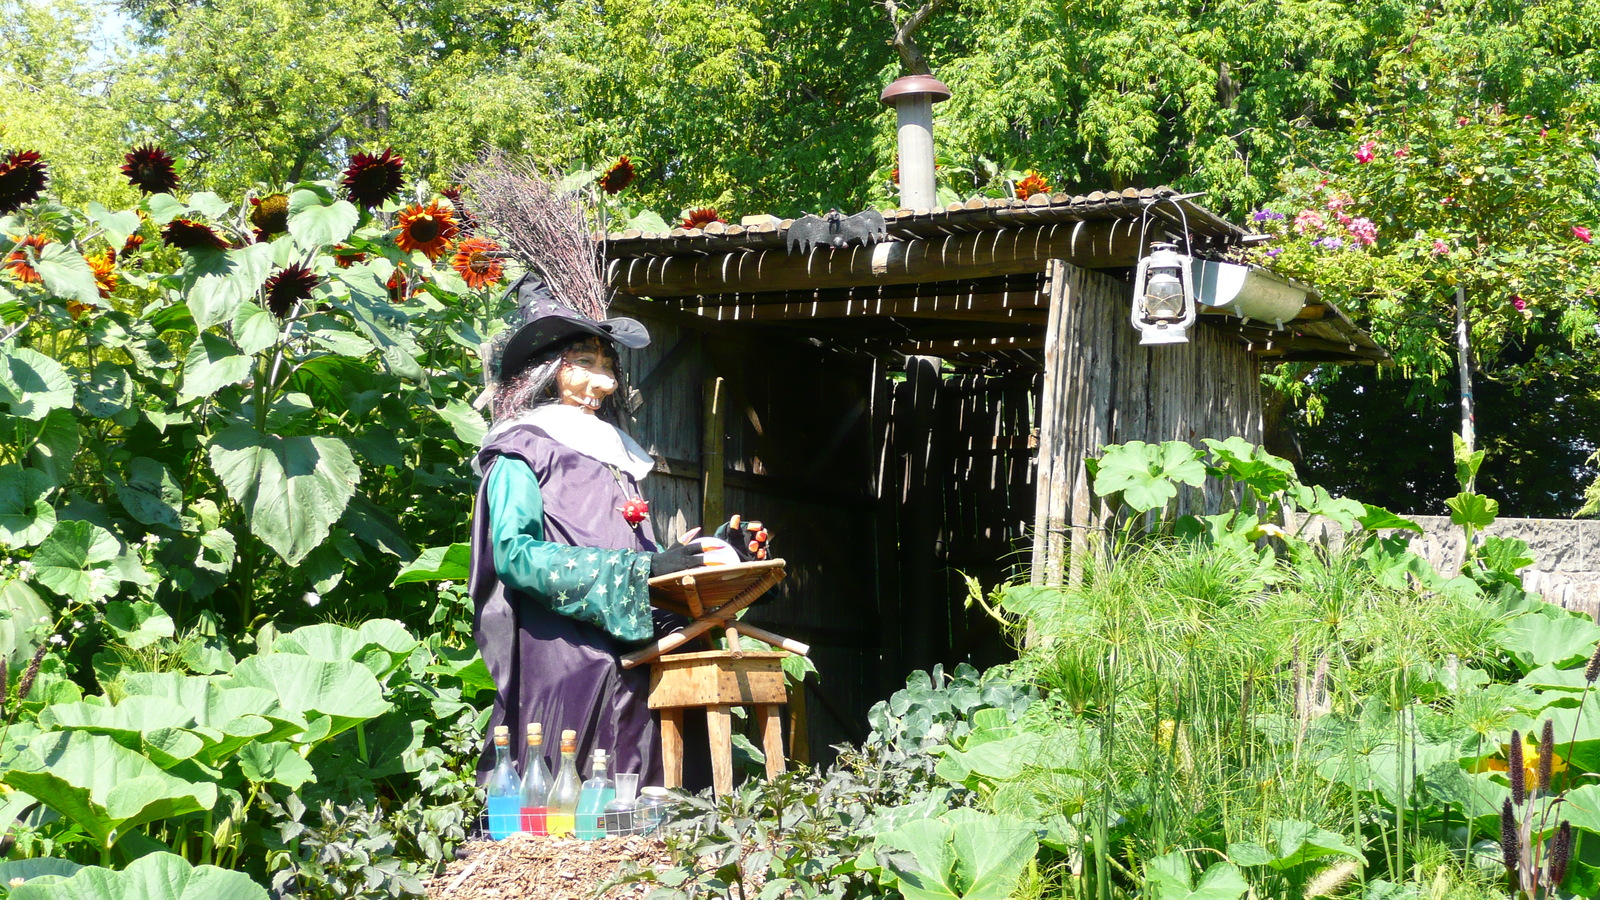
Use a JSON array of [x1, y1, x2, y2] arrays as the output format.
[[1410, 516, 1600, 620]]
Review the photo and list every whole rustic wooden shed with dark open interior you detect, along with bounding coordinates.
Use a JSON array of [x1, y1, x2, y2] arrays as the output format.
[[606, 189, 1387, 757]]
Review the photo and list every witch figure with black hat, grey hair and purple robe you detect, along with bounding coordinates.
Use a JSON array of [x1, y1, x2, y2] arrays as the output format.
[[469, 264, 723, 783]]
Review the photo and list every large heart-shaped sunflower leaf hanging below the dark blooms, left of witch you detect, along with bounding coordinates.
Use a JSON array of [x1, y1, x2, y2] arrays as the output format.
[[211, 424, 362, 565]]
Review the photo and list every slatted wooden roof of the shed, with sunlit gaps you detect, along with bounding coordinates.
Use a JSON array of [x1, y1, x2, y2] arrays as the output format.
[[605, 187, 1389, 368]]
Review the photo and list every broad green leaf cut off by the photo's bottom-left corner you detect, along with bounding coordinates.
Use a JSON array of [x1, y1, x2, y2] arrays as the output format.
[[11, 854, 267, 900]]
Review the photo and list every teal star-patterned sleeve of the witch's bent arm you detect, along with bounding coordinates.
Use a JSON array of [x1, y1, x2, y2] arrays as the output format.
[[486, 458, 653, 641]]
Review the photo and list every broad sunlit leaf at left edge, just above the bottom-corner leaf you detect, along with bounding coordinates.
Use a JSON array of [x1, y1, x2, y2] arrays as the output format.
[[0, 732, 216, 846]]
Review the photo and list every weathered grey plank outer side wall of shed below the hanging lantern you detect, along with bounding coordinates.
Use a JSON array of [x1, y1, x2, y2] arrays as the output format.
[[1034, 259, 1262, 581]]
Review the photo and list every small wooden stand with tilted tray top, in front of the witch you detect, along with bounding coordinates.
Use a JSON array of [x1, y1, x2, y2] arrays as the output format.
[[636, 559, 811, 794]]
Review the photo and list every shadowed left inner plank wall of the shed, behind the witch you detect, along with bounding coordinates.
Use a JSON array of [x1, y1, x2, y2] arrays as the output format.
[[622, 303, 886, 761]]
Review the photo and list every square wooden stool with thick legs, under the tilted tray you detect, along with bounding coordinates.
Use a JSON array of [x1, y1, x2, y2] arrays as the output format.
[[650, 650, 789, 794]]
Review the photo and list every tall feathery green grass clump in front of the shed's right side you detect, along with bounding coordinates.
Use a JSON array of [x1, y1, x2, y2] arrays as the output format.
[[987, 541, 1501, 900]]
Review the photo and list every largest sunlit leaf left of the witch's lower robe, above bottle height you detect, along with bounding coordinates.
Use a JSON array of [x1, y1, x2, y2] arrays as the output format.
[[229, 653, 389, 735]]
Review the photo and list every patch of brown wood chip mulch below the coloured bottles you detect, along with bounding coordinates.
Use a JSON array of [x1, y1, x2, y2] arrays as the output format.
[[426, 833, 669, 900]]
